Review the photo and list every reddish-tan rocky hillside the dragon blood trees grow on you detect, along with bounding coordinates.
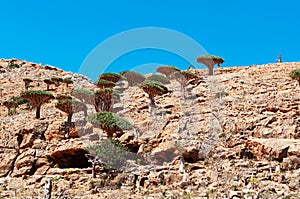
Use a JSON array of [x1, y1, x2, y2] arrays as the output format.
[[0, 59, 300, 199]]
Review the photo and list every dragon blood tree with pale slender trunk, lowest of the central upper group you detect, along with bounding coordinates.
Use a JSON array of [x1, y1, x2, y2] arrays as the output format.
[[138, 81, 168, 113]]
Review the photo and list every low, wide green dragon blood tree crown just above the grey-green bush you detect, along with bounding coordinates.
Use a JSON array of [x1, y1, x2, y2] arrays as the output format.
[[88, 112, 133, 138]]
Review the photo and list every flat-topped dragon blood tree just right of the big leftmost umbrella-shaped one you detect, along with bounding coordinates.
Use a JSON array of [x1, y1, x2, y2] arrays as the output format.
[[55, 99, 87, 126]]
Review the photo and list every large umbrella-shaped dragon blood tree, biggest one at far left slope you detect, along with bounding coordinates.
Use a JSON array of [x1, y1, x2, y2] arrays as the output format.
[[20, 90, 54, 119]]
